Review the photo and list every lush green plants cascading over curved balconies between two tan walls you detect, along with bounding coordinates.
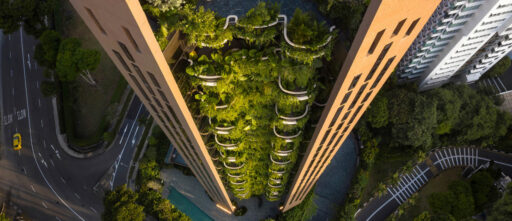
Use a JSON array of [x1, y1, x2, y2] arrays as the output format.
[[152, 2, 334, 200]]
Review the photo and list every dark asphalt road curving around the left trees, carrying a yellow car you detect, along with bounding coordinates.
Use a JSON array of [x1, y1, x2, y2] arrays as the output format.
[[0, 27, 148, 220]]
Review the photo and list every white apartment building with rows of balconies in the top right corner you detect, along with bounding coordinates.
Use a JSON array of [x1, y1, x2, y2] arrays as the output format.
[[397, 0, 512, 90]]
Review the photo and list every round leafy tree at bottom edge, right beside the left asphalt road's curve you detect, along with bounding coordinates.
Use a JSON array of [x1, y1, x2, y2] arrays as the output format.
[[102, 185, 146, 221]]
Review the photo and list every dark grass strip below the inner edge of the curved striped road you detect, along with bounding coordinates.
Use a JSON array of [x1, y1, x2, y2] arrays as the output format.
[[399, 168, 463, 221]]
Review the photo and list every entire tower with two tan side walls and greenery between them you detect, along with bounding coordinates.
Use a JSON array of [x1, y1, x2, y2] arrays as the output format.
[[71, 0, 440, 212]]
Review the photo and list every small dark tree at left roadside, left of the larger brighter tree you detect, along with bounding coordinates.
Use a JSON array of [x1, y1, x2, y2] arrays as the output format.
[[34, 30, 61, 69]]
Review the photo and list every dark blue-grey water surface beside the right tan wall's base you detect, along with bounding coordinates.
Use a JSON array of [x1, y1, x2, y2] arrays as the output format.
[[311, 134, 357, 220]]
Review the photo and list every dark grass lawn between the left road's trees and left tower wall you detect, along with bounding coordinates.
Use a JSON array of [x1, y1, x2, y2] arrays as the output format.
[[57, 0, 126, 144]]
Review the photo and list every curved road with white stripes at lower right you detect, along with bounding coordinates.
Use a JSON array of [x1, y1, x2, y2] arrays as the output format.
[[355, 147, 512, 221]]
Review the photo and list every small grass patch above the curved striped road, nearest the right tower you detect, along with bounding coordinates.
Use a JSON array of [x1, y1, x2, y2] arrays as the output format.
[[361, 148, 411, 202]]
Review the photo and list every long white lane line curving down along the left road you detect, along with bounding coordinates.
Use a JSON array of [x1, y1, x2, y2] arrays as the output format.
[[20, 27, 85, 221]]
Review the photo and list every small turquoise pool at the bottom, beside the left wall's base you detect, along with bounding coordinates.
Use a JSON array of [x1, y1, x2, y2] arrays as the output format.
[[167, 187, 213, 221]]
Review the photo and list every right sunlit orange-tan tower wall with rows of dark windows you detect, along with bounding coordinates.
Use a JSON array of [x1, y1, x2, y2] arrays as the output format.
[[283, 0, 440, 211]]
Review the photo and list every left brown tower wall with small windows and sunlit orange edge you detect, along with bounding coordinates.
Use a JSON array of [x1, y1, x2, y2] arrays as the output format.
[[70, 0, 233, 213]]
